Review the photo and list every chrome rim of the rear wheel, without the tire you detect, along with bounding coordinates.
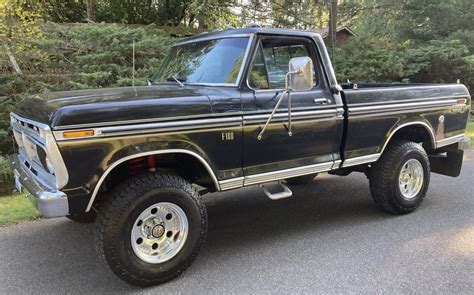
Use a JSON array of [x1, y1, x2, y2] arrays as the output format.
[[398, 159, 424, 200]]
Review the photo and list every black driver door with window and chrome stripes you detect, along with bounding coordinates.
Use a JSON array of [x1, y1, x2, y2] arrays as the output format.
[[242, 36, 342, 185]]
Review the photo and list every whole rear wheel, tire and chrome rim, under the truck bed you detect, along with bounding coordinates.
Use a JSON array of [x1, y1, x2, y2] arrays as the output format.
[[370, 140, 430, 214]]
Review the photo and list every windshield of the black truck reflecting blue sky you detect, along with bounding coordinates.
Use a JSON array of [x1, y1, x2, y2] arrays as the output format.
[[153, 38, 249, 84]]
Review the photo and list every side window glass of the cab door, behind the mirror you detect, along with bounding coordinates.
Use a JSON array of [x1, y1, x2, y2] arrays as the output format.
[[249, 38, 318, 89]]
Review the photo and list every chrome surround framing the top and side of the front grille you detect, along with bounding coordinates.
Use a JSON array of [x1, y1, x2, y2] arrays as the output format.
[[10, 113, 69, 189]]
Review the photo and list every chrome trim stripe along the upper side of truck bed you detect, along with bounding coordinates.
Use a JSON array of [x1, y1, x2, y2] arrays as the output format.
[[348, 99, 457, 116]]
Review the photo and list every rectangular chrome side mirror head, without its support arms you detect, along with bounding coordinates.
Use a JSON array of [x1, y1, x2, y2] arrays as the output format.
[[286, 56, 313, 91]]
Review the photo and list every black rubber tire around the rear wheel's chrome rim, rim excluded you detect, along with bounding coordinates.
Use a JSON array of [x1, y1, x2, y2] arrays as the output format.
[[369, 140, 430, 214]]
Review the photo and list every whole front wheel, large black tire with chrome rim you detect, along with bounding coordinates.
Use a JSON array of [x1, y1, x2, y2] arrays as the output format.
[[96, 174, 207, 286]]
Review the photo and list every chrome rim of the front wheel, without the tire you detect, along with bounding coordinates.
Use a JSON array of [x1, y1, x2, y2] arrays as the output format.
[[131, 202, 189, 264]]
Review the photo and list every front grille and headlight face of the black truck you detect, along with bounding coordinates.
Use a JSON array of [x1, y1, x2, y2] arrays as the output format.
[[10, 114, 56, 188]]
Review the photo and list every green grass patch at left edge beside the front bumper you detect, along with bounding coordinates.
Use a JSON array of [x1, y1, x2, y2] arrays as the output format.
[[0, 194, 41, 226]]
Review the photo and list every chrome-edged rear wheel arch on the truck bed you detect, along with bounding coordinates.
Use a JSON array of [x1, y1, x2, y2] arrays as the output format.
[[380, 121, 436, 154]]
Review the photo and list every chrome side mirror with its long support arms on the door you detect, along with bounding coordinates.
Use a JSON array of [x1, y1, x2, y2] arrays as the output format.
[[257, 56, 313, 140]]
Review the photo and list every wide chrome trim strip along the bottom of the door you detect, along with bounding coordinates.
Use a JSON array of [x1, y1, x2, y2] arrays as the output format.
[[244, 161, 334, 186]]
